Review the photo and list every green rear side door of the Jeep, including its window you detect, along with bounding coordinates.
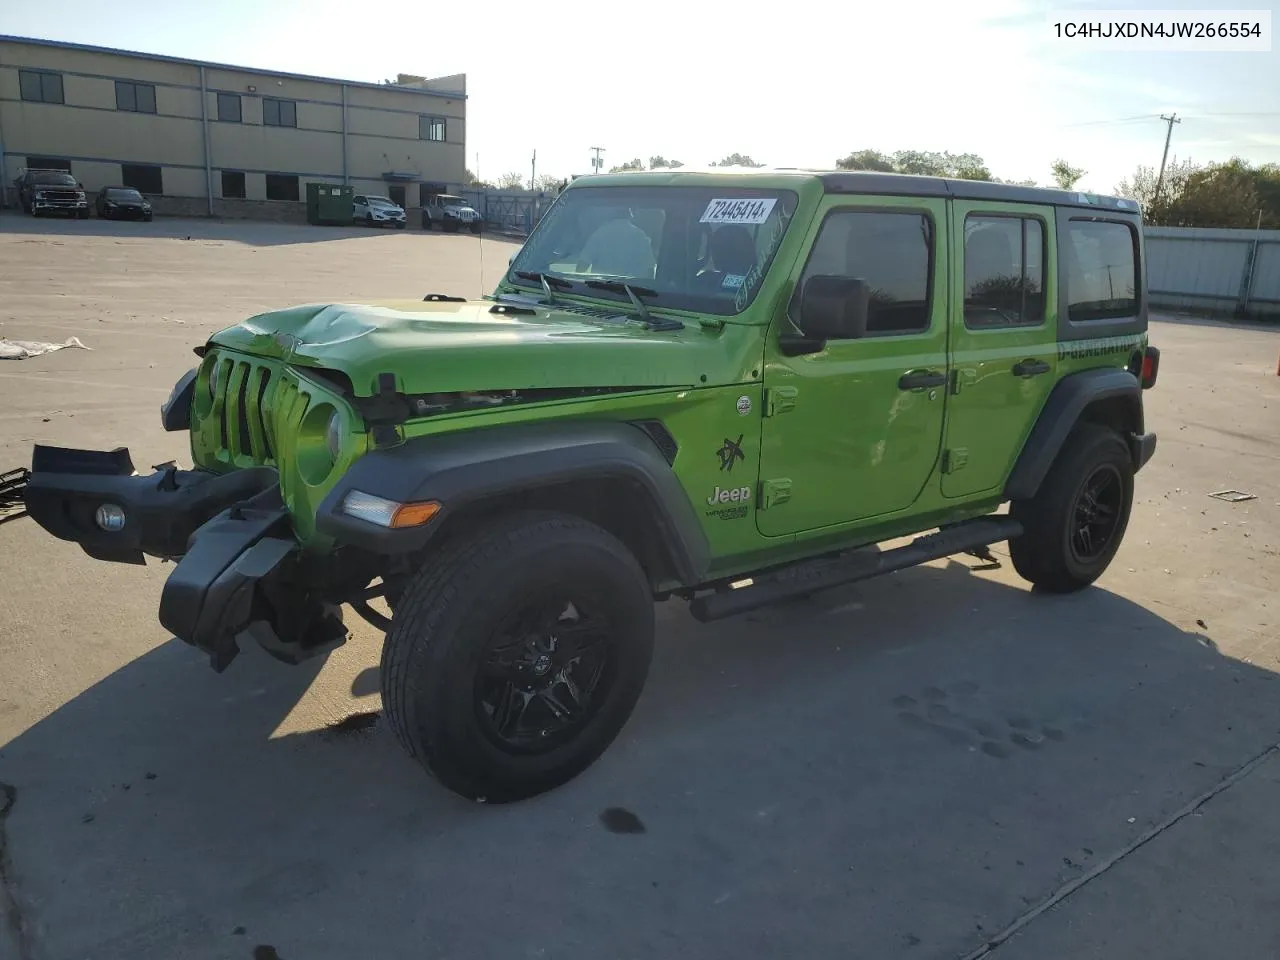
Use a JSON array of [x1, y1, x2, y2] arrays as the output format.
[[942, 200, 1057, 498]]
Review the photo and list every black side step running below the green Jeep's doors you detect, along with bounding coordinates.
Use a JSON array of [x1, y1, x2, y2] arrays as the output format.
[[689, 516, 1023, 623]]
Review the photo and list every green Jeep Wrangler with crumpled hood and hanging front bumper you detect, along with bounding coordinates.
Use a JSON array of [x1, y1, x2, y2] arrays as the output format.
[[23, 170, 1158, 803]]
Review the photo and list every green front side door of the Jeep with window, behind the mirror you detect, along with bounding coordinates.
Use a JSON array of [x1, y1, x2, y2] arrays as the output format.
[[756, 197, 947, 536]]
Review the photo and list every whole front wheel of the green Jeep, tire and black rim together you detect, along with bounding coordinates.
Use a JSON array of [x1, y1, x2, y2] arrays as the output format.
[[381, 513, 653, 803]]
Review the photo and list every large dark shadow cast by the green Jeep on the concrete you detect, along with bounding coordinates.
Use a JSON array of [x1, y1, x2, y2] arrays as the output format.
[[0, 561, 1280, 960]]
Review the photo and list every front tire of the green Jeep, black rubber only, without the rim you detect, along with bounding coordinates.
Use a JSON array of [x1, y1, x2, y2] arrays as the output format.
[[381, 512, 654, 803]]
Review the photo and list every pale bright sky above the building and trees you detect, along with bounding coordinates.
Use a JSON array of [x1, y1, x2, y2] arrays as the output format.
[[0, 0, 1280, 192]]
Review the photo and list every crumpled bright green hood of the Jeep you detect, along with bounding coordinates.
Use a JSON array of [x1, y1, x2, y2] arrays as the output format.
[[210, 301, 762, 397]]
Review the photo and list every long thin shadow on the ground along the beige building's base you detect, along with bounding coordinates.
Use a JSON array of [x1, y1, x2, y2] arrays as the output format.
[[0, 210, 432, 247]]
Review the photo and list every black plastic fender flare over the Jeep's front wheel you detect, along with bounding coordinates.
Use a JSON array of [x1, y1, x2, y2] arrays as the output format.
[[316, 421, 710, 585]]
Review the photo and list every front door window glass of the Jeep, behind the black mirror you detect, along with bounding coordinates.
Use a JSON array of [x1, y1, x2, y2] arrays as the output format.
[[791, 210, 933, 337]]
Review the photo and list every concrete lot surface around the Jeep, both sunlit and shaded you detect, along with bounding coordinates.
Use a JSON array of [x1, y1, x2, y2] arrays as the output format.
[[0, 216, 1280, 960]]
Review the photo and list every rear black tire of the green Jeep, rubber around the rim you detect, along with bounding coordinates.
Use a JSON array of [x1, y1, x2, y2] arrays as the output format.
[[1009, 424, 1133, 593]]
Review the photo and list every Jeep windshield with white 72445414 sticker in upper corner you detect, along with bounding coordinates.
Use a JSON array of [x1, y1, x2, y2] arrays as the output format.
[[508, 186, 797, 315]]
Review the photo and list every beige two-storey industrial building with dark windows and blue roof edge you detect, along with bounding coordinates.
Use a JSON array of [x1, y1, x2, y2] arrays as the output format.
[[0, 36, 466, 220]]
